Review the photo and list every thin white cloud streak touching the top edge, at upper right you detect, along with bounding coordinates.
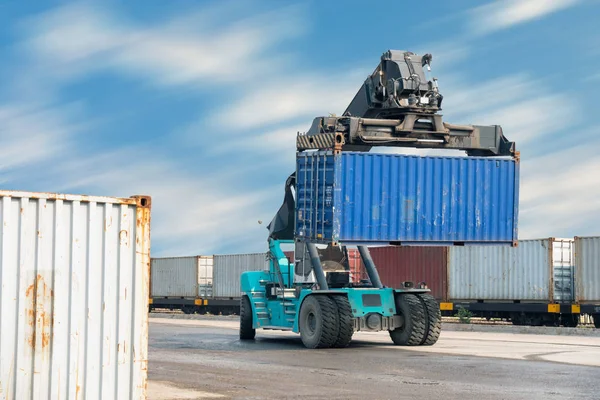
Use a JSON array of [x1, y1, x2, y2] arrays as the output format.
[[470, 0, 579, 34]]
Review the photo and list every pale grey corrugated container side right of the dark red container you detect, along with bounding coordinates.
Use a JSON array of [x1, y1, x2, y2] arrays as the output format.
[[448, 239, 553, 301]]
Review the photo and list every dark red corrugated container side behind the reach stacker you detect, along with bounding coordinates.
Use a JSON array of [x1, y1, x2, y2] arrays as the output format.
[[369, 246, 448, 301]]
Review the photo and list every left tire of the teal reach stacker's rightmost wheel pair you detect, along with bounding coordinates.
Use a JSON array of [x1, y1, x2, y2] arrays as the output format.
[[390, 293, 426, 346]]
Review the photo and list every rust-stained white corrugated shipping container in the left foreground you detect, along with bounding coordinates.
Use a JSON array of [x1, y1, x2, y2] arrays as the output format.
[[0, 191, 150, 400]]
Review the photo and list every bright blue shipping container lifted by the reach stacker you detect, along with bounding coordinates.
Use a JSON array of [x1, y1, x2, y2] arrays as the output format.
[[296, 151, 519, 245]]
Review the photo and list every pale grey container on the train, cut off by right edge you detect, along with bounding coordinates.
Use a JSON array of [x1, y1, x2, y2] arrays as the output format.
[[575, 236, 600, 304]]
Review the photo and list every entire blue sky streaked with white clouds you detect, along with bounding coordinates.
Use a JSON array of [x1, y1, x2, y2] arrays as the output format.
[[0, 0, 600, 256]]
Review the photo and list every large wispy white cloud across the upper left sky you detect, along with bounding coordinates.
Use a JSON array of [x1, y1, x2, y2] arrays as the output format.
[[23, 4, 304, 85]]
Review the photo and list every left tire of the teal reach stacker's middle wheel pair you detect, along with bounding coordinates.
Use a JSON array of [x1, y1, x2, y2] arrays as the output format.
[[298, 295, 339, 349]]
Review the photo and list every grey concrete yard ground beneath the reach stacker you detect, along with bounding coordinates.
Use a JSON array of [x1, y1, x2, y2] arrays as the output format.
[[148, 318, 600, 400]]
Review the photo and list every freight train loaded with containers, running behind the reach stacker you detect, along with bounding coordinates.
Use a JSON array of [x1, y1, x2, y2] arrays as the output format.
[[150, 237, 600, 328]]
